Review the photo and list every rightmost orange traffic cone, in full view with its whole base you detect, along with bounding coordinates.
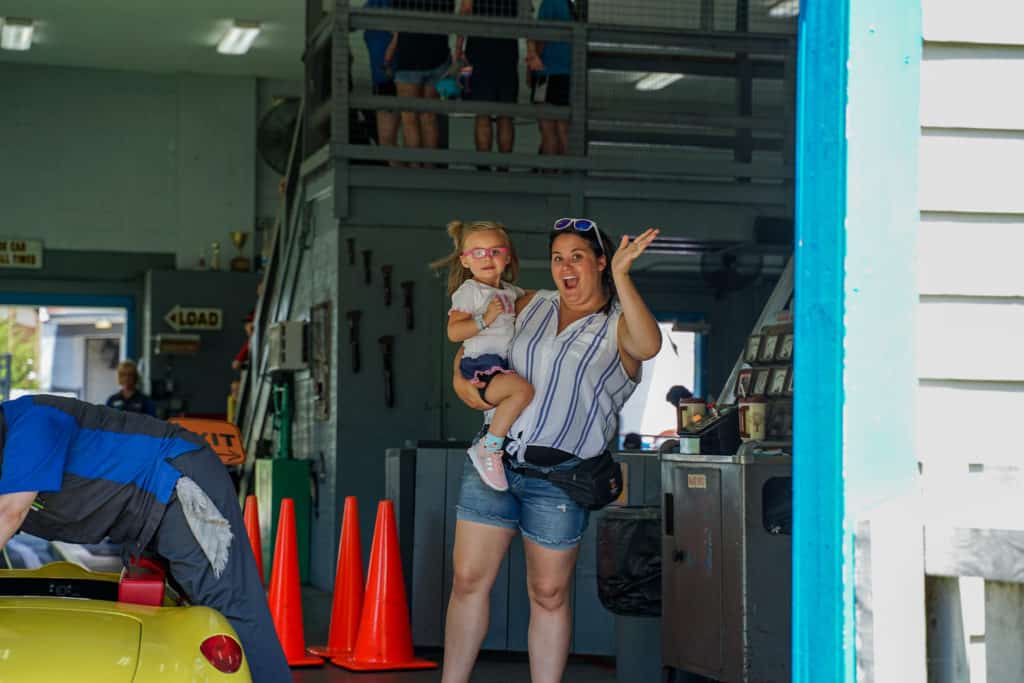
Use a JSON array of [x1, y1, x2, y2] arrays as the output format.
[[331, 501, 437, 671]]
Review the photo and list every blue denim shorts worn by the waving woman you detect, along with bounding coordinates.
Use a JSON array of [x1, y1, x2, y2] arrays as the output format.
[[456, 457, 590, 550]]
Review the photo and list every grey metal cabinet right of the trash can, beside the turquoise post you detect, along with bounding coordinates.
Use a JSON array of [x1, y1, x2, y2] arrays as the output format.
[[662, 454, 792, 683]]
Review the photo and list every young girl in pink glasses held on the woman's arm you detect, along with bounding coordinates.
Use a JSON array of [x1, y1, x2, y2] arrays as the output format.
[[431, 221, 534, 490]]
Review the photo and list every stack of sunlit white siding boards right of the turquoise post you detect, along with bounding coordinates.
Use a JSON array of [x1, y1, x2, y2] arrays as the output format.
[[915, 0, 1024, 481]]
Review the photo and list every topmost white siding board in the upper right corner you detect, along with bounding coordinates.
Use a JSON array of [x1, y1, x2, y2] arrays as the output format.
[[922, 0, 1024, 45]]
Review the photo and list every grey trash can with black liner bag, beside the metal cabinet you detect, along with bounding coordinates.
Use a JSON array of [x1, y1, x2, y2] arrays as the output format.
[[597, 507, 662, 683]]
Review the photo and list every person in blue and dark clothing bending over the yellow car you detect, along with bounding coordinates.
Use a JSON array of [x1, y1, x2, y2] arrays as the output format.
[[0, 394, 292, 683]]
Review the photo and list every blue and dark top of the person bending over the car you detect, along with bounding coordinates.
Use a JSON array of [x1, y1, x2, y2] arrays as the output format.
[[0, 395, 206, 553]]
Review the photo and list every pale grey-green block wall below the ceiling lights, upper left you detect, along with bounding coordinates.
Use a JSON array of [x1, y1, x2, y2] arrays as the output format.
[[0, 63, 298, 268]]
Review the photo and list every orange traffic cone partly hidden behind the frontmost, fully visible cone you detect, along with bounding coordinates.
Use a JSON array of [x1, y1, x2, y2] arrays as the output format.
[[308, 496, 362, 657]]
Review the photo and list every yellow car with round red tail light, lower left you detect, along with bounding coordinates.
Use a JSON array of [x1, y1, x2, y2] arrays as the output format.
[[0, 562, 251, 683]]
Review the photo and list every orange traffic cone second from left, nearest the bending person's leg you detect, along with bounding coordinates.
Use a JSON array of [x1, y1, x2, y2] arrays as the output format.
[[269, 498, 324, 667]]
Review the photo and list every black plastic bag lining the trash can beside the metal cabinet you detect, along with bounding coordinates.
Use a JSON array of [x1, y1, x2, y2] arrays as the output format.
[[597, 507, 662, 616]]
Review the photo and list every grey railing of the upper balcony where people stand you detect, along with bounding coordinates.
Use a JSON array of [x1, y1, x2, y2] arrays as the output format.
[[304, 0, 796, 211]]
